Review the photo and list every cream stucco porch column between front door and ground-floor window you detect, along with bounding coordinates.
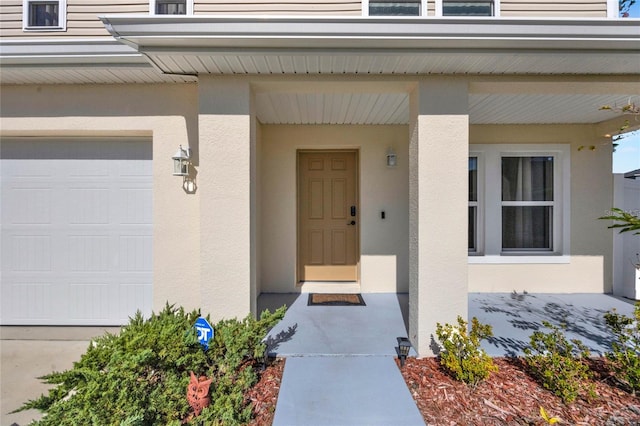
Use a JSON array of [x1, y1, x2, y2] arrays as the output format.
[[409, 78, 469, 357]]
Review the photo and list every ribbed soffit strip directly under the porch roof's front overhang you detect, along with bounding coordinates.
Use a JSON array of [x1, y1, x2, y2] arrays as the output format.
[[151, 52, 640, 75]]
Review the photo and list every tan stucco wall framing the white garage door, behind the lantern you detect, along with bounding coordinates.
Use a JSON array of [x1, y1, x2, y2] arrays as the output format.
[[0, 85, 200, 310]]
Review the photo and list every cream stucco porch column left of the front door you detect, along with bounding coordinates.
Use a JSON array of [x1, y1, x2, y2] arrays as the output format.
[[198, 77, 256, 321]]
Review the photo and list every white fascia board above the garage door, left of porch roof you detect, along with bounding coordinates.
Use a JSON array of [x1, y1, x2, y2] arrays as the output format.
[[0, 38, 147, 66]]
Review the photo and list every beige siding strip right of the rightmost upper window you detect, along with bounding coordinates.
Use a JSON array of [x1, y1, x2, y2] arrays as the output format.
[[500, 0, 607, 18]]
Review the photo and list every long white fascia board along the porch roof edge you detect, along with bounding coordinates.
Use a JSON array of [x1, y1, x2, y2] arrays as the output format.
[[100, 15, 640, 53]]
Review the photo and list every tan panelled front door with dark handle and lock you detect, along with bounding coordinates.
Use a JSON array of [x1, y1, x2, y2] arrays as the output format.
[[298, 151, 359, 281]]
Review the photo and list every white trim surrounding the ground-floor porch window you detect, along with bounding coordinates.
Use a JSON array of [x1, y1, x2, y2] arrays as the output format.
[[469, 144, 571, 263]]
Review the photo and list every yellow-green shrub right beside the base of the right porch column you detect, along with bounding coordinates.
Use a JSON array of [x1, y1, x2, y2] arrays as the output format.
[[436, 316, 498, 386]]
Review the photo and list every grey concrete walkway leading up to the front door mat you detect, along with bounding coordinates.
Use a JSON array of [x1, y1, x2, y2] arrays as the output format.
[[261, 294, 424, 426]]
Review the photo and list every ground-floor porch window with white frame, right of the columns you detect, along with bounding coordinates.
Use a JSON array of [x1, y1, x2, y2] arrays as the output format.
[[469, 145, 570, 256]]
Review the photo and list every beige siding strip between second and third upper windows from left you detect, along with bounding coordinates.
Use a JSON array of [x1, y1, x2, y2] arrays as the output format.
[[193, 0, 362, 15]]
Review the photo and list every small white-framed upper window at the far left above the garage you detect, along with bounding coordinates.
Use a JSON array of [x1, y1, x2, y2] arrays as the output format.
[[22, 0, 67, 31]]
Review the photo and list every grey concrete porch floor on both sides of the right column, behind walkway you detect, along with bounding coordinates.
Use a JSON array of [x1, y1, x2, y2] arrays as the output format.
[[258, 293, 634, 357]]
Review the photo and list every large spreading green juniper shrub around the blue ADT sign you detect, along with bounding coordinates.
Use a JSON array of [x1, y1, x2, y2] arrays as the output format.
[[15, 306, 285, 426]]
